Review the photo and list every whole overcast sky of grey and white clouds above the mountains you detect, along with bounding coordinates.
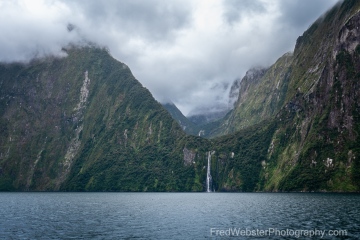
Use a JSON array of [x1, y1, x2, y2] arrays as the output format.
[[0, 0, 337, 115]]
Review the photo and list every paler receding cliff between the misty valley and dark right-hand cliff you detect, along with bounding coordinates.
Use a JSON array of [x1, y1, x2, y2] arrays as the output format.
[[210, 53, 293, 137]]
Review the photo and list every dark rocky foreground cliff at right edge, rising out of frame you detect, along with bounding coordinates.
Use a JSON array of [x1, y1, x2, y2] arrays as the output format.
[[264, 1, 360, 191]]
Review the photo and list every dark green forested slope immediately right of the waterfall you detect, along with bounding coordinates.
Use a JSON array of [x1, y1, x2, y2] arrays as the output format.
[[212, 121, 276, 191]]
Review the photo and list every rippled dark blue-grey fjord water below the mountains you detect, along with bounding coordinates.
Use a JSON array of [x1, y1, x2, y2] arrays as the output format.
[[0, 193, 360, 239]]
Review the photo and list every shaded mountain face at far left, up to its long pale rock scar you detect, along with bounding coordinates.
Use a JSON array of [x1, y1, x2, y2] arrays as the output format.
[[0, 50, 102, 190]]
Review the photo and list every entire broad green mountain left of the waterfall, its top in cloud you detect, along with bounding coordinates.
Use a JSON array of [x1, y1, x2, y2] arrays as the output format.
[[0, 46, 211, 191]]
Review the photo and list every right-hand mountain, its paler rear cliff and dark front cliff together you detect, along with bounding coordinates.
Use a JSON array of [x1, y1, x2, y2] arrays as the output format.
[[212, 0, 360, 191]]
